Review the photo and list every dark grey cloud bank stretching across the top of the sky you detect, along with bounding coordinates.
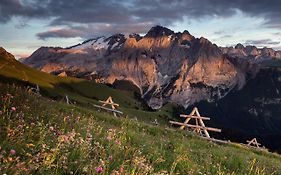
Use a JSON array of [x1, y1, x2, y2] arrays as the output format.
[[0, 0, 281, 38]]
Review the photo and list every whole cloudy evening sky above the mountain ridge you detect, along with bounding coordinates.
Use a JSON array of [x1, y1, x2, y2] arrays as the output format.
[[0, 0, 281, 58]]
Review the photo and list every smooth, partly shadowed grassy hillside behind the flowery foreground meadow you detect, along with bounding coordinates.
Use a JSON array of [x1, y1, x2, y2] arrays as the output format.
[[0, 55, 177, 123]]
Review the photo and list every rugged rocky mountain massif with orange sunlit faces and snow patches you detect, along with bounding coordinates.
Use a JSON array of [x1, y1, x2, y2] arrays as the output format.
[[24, 26, 280, 109]]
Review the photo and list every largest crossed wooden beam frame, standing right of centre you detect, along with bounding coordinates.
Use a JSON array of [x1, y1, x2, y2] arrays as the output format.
[[170, 107, 221, 138]]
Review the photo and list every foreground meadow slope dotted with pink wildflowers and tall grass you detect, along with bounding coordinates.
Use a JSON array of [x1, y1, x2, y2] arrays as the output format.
[[0, 84, 281, 175]]
